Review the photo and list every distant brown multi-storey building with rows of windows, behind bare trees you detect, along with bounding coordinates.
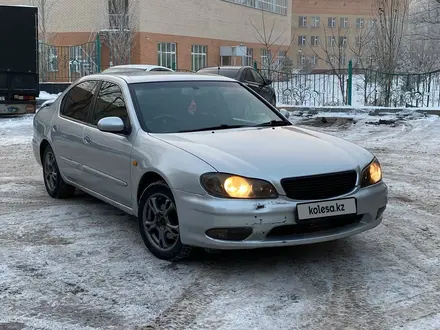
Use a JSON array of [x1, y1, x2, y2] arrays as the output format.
[[289, 0, 374, 71]]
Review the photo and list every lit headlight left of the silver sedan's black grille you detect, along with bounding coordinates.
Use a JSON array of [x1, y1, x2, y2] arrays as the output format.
[[200, 173, 278, 199]]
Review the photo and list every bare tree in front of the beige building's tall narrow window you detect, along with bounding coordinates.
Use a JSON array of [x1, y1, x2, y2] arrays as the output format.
[[103, 0, 139, 65]]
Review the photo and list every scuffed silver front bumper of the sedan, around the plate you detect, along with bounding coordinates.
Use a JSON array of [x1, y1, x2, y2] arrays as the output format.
[[173, 182, 388, 250]]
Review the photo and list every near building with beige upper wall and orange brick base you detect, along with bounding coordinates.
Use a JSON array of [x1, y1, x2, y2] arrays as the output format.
[[2, 0, 292, 77]]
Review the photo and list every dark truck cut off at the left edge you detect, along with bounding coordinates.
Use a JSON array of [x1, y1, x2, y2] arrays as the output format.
[[0, 5, 40, 117]]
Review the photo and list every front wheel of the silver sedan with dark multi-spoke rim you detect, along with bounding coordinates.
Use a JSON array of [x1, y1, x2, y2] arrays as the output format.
[[138, 181, 192, 261]]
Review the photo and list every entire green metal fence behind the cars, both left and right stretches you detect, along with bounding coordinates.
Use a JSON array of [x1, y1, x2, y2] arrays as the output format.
[[35, 39, 440, 108]]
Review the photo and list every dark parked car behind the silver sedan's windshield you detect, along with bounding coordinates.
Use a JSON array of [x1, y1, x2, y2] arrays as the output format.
[[197, 66, 277, 106]]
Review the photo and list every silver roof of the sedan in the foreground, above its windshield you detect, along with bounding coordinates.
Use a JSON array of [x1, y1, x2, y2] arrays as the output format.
[[80, 71, 236, 84]]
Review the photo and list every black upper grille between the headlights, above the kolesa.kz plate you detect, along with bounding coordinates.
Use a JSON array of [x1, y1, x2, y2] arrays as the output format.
[[281, 171, 357, 200]]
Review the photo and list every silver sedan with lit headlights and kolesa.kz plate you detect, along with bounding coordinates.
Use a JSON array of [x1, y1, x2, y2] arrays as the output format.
[[32, 72, 388, 260]]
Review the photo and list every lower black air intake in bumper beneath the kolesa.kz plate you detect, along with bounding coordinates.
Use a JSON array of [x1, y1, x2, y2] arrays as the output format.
[[266, 214, 363, 239]]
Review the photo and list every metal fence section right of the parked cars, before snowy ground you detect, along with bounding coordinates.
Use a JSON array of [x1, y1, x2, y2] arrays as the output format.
[[271, 70, 440, 108]]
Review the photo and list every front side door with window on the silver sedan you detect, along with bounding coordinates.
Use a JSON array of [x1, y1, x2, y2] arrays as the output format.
[[82, 81, 132, 207]]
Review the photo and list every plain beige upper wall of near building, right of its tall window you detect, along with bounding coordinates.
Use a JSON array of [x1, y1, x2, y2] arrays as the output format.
[[141, 0, 292, 44]]
